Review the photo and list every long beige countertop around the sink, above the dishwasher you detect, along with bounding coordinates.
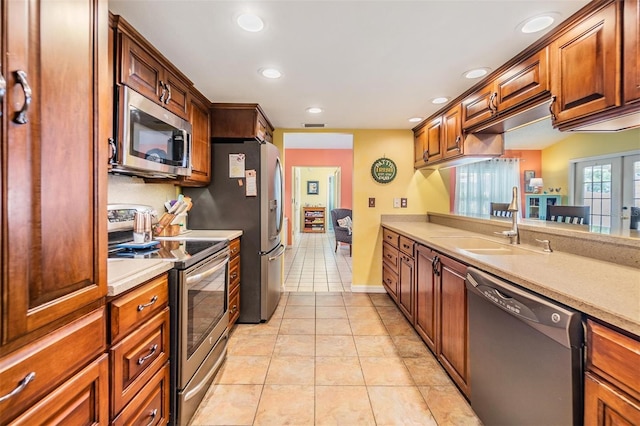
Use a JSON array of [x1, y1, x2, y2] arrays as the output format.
[[382, 219, 640, 336]]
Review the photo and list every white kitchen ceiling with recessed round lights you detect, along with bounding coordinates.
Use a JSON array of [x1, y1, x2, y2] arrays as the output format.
[[109, 0, 587, 136]]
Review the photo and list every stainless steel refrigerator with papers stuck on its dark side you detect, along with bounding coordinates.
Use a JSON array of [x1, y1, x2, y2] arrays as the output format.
[[183, 140, 285, 323]]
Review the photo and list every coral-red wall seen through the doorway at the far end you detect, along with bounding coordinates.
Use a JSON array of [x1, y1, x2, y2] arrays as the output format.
[[284, 149, 353, 241]]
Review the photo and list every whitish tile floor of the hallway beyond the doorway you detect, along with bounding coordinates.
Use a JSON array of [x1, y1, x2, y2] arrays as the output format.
[[284, 230, 351, 292]]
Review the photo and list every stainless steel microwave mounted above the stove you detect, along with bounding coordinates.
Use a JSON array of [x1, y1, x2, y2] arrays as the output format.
[[109, 86, 191, 178]]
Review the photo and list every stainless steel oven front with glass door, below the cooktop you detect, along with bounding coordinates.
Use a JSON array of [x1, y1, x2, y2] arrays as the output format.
[[169, 245, 229, 425]]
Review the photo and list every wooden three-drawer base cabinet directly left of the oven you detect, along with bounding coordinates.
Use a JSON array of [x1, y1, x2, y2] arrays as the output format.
[[108, 273, 170, 424]]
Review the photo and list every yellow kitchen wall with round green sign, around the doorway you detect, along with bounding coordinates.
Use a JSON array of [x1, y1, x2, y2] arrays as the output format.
[[274, 129, 449, 291]]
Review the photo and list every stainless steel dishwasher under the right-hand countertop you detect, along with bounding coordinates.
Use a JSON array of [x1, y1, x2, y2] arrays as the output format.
[[466, 267, 584, 426]]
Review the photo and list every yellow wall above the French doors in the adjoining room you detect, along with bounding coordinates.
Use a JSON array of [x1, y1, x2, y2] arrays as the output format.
[[542, 129, 640, 192]]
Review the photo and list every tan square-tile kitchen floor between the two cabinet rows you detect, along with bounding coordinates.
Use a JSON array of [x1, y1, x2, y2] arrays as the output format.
[[191, 292, 480, 426]]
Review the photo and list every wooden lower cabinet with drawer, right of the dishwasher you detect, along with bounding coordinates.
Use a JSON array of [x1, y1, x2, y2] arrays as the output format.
[[584, 320, 640, 426]]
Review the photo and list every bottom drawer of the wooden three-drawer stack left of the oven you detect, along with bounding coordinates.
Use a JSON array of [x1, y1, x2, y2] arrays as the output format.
[[112, 364, 169, 425]]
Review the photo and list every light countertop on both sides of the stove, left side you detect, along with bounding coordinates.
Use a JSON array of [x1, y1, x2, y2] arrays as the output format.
[[107, 230, 242, 296]]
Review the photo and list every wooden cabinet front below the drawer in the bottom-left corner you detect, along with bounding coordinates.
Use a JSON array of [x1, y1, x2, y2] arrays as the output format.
[[8, 354, 109, 426]]
